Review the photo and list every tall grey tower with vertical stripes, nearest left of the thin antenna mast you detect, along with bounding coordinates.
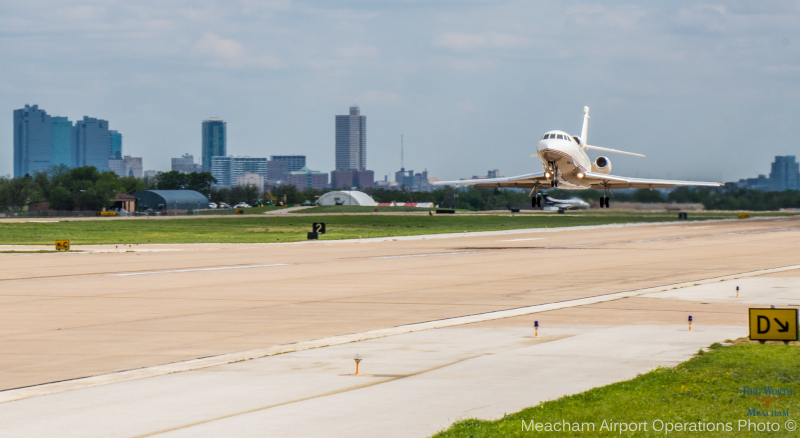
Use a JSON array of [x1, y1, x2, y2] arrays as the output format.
[[336, 106, 367, 171]]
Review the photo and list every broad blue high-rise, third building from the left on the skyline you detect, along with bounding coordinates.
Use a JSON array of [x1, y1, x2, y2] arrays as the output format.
[[72, 116, 109, 172]]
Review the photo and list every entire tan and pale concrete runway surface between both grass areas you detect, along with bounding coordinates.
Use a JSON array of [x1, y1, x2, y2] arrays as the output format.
[[0, 218, 800, 436]]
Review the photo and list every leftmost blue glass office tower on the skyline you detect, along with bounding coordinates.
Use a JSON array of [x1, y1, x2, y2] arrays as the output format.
[[14, 105, 52, 177]]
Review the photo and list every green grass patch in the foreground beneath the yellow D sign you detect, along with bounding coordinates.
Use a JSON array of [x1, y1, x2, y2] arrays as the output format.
[[435, 344, 800, 438]]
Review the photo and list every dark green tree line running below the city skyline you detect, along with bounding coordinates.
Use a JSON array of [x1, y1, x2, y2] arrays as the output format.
[[0, 169, 800, 211]]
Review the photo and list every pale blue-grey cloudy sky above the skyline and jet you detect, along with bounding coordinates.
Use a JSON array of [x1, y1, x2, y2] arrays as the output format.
[[0, 0, 800, 181]]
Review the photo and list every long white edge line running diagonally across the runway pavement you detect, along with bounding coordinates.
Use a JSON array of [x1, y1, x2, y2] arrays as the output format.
[[0, 265, 800, 403]]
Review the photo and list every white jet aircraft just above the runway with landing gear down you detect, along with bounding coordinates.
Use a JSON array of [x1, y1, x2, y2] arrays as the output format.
[[434, 106, 723, 208]]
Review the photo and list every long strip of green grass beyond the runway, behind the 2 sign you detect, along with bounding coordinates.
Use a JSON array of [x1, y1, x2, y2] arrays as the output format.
[[0, 212, 792, 245]]
